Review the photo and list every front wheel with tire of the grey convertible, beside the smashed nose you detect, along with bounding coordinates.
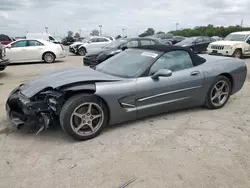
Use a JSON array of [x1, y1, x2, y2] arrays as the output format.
[[59, 94, 109, 141]]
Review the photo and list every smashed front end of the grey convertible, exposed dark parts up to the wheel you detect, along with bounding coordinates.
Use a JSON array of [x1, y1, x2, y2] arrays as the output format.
[[6, 85, 64, 134]]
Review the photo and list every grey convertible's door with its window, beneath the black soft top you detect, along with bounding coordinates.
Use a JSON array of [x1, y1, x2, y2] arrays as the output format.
[[136, 50, 206, 118]]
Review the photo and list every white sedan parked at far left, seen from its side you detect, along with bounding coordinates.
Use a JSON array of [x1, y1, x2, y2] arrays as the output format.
[[6, 39, 66, 63]]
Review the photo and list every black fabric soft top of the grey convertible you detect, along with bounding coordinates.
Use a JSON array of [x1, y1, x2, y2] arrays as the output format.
[[136, 45, 206, 66]]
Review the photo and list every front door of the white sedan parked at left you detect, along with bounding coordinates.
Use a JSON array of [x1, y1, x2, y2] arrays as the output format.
[[6, 40, 30, 62]]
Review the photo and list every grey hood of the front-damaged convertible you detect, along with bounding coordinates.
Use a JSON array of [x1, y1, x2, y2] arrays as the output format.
[[21, 67, 122, 98]]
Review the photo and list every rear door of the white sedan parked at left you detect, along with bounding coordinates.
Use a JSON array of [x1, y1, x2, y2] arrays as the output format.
[[27, 40, 45, 61]]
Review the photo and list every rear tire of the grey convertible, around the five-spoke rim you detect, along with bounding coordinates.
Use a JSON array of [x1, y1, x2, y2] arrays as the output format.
[[205, 76, 232, 109]]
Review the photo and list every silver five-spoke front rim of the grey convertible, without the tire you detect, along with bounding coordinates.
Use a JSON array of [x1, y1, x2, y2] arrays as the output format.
[[70, 103, 104, 136]]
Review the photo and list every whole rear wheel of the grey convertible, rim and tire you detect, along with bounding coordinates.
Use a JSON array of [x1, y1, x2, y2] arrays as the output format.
[[205, 76, 232, 109]]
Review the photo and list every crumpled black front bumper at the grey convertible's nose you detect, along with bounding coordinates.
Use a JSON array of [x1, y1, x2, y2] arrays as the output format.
[[5, 85, 50, 129]]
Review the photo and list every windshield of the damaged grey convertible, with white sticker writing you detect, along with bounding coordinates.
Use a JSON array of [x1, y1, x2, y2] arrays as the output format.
[[96, 49, 161, 78]]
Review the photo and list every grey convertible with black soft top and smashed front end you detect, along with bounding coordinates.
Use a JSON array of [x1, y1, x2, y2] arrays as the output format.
[[6, 45, 247, 140]]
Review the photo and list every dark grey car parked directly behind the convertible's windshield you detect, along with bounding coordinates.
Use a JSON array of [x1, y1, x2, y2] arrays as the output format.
[[83, 37, 160, 67]]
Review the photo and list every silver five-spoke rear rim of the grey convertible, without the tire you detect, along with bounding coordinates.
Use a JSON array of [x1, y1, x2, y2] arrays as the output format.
[[211, 80, 230, 107]]
